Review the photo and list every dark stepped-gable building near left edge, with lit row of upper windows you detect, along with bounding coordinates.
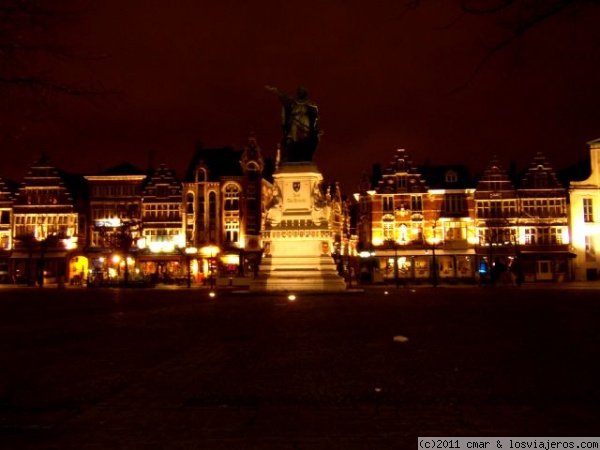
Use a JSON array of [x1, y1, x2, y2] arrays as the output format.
[[11, 154, 81, 285]]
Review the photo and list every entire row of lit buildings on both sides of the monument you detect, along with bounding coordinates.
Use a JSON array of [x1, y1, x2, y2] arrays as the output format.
[[0, 136, 600, 286]]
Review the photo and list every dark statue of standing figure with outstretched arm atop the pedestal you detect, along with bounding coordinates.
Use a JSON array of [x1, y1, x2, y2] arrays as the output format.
[[265, 86, 321, 162]]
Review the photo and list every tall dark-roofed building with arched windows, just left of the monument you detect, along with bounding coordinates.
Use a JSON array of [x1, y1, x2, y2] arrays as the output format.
[[183, 135, 273, 277]]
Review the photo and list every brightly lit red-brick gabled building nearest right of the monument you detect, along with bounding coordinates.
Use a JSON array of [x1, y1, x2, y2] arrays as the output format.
[[358, 149, 475, 283]]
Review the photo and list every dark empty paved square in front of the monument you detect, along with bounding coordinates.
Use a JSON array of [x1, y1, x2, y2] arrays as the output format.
[[0, 288, 600, 450]]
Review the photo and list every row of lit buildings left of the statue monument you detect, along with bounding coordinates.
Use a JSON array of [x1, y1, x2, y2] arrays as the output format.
[[0, 136, 284, 286]]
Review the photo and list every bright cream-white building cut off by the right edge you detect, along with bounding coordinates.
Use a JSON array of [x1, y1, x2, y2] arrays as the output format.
[[569, 139, 600, 281]]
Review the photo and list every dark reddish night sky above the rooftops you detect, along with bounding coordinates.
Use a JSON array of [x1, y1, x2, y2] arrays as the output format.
[[0, 0, 600, 193]]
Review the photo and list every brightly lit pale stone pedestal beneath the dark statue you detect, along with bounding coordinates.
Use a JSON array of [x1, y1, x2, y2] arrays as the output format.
[[250, 163, 346, 292]]
